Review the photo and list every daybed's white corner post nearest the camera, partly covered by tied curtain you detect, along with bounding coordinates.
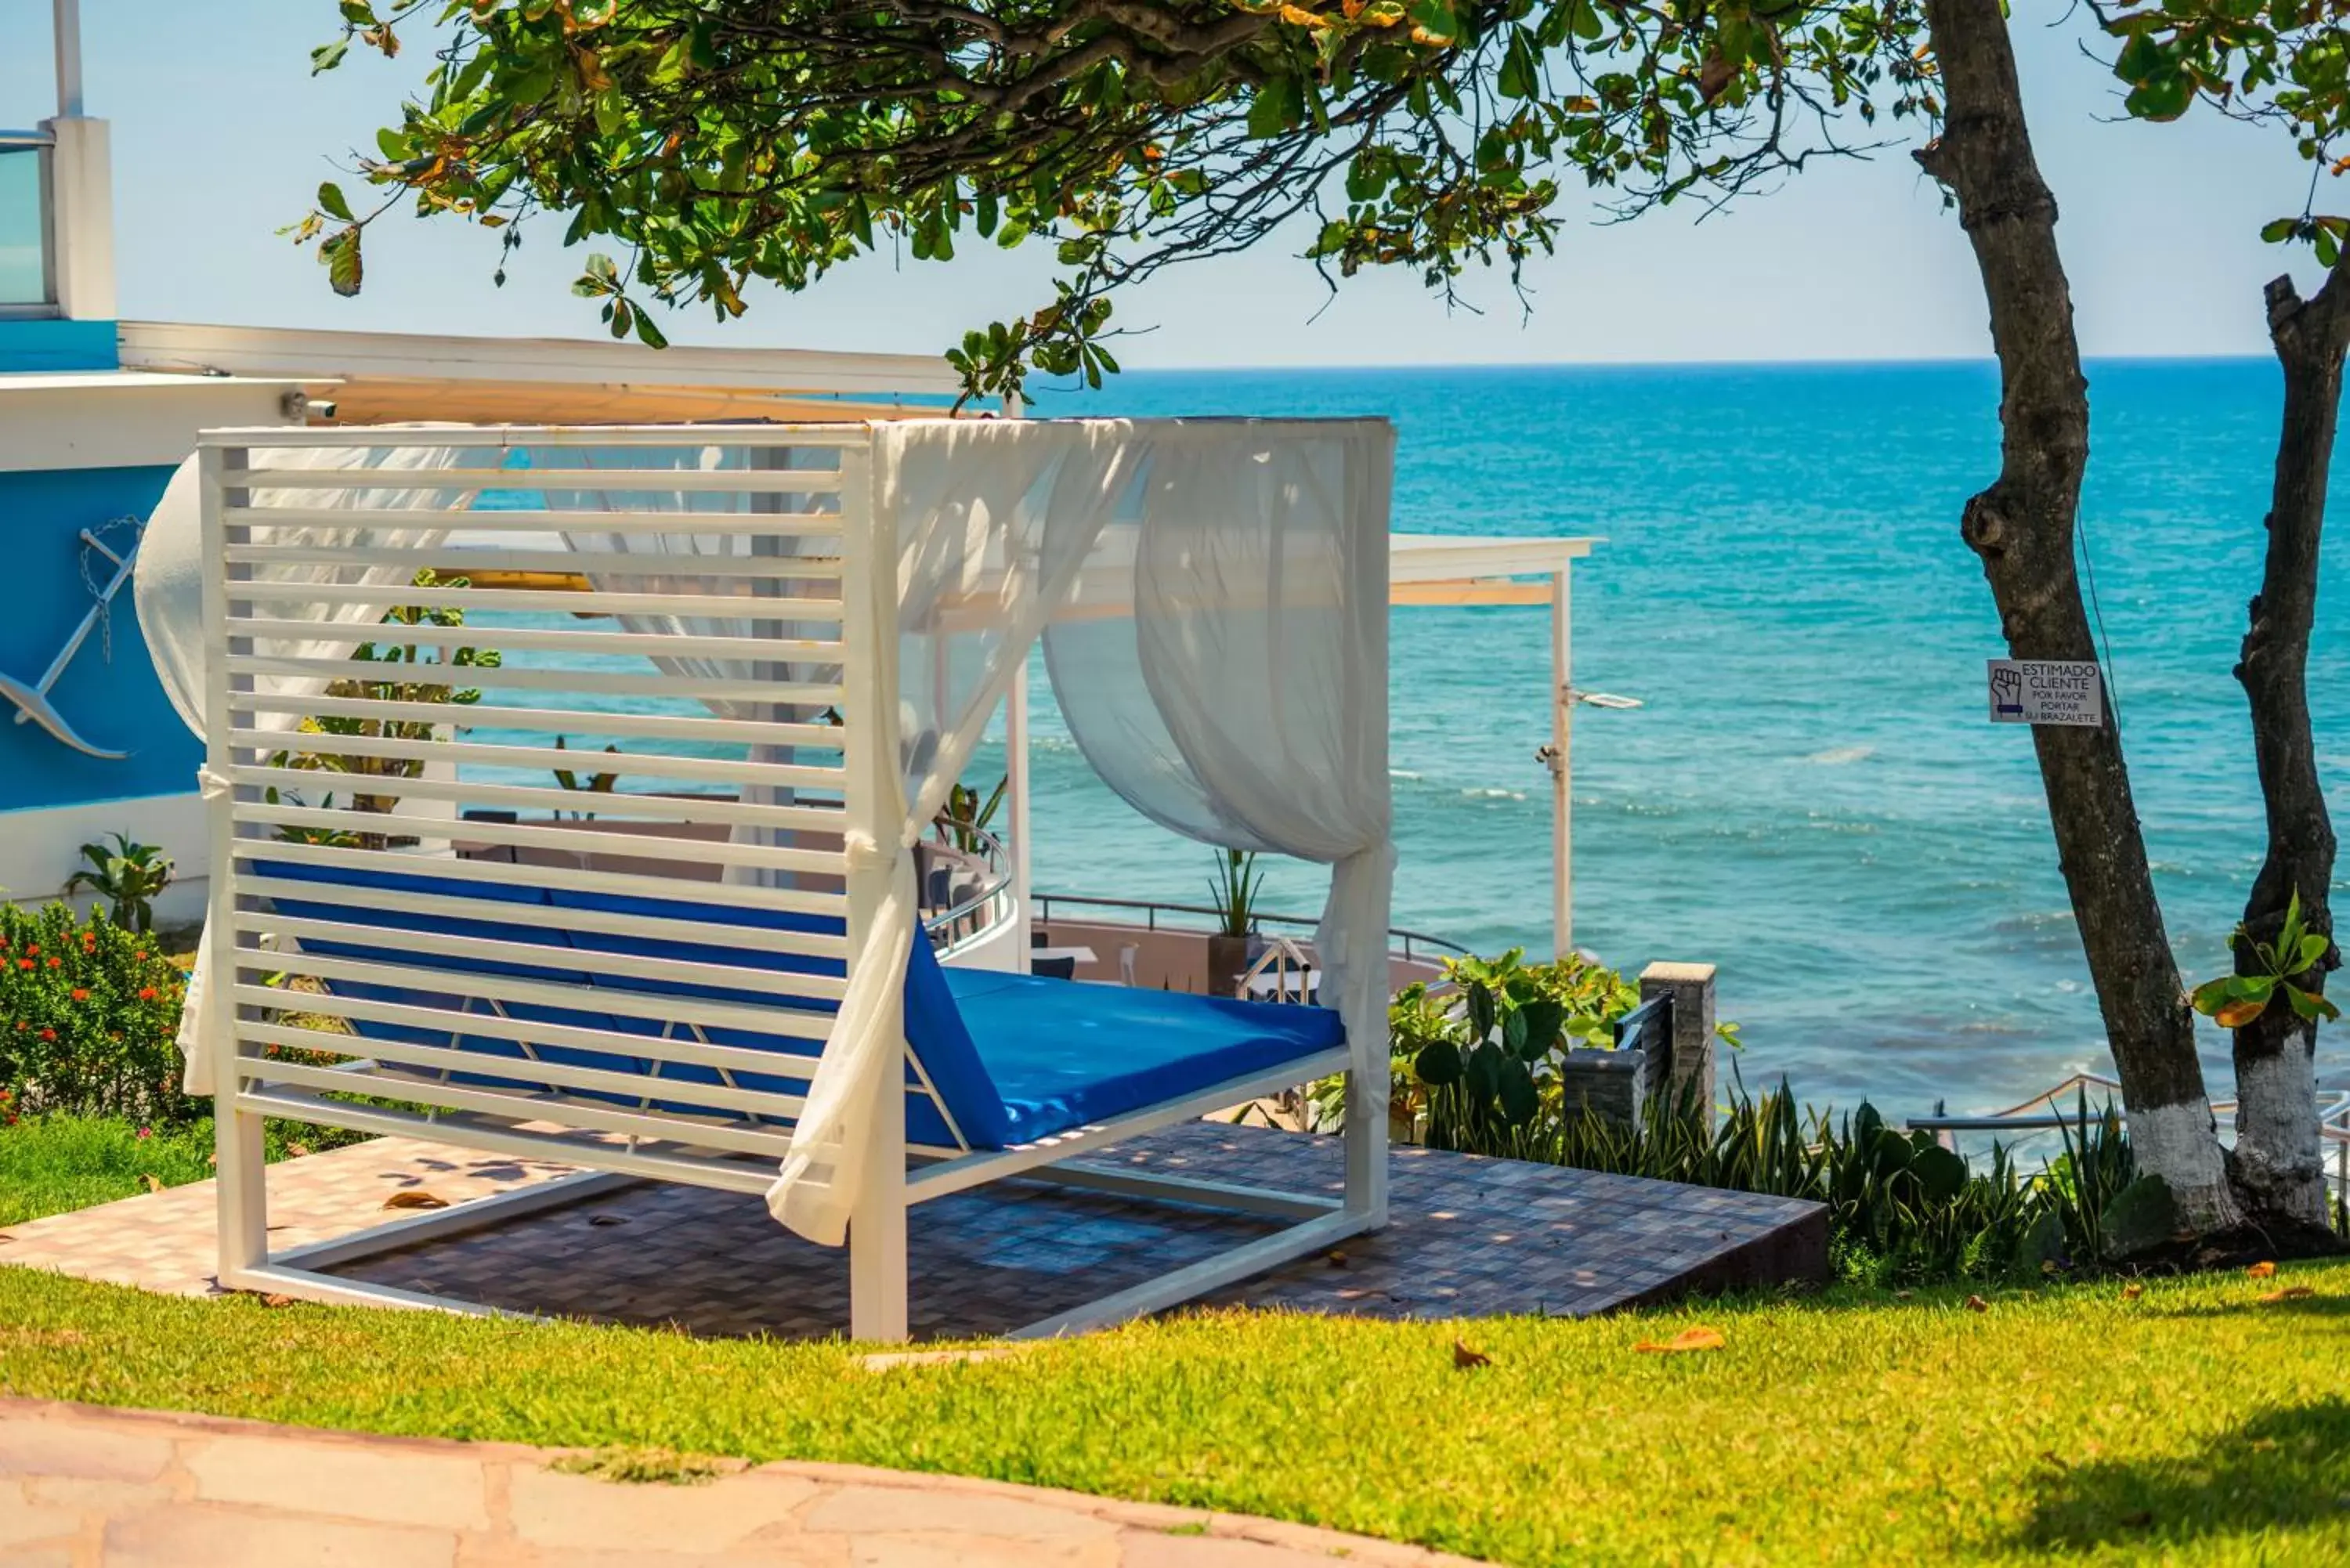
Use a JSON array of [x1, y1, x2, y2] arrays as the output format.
[[841, 435, 924, 1342]]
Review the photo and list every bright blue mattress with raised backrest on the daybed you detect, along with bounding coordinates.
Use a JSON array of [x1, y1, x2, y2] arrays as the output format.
[[256, 863, 1344, 1150]]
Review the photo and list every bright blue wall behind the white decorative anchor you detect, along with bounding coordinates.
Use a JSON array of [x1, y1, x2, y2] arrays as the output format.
[[0, 465, 202, 811]]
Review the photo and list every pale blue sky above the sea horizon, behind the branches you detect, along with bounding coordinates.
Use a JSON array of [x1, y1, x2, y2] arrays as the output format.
[[0, 0, 2310, 367]]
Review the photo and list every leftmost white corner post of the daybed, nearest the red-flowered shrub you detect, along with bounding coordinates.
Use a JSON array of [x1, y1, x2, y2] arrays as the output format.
[[197, 446, 270, 1288]]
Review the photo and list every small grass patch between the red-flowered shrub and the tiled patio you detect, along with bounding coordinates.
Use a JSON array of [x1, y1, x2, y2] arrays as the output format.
[[0, 1117, 350, 1227]]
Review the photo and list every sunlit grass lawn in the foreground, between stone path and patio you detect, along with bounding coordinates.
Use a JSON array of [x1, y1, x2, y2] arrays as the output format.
[[0, 1265, 2350, 1568]]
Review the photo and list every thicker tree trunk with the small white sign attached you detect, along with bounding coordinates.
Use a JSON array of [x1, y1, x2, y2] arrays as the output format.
[[1918, 0, 2240, 1237]]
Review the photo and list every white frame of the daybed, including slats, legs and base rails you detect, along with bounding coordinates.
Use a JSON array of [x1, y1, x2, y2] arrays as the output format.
[[200, 425, 1386, 1340]]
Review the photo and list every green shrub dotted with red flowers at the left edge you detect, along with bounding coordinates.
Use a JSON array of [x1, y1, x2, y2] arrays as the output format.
[[0, 903, 193, 1126]]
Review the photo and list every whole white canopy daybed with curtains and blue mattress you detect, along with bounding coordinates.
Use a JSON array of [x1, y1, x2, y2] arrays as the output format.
[[139, 418, 1394, 1340]]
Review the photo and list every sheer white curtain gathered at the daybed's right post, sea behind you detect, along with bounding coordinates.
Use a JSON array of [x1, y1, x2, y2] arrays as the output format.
[[1043, 421, 1394, 1142]]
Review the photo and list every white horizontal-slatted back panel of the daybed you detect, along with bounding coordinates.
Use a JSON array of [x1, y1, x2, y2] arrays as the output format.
[[190, 425, 952, 1170]]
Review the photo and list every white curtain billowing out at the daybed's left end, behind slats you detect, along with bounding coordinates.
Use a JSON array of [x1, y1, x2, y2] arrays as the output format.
[[132, 446, 501, 1096]]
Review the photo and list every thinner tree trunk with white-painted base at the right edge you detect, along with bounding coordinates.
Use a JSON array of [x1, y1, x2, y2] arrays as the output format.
[[2232, 258, 2350, 1251]]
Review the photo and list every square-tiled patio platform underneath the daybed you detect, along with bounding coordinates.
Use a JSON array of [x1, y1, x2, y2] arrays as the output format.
[[0, 1122, 1826, 1338]]
